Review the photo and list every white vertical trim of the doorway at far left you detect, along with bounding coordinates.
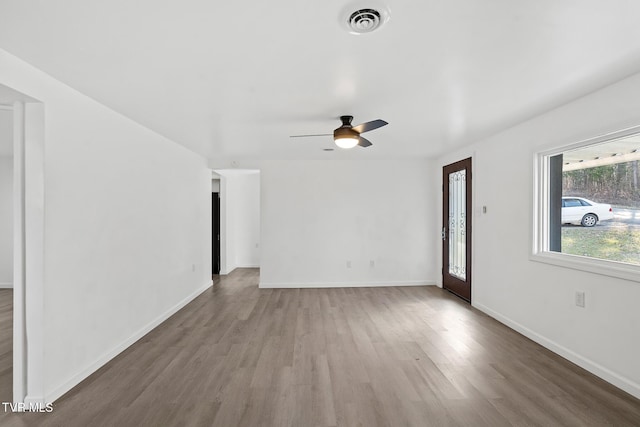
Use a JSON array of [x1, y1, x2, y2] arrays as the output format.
[[13, 100, 44, 403]]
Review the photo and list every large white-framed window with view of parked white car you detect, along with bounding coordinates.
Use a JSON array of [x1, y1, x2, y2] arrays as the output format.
[[532, 127, 640, 281]]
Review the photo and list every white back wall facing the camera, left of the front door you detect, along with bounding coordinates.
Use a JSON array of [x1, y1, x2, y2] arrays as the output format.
[[260, 160, 440, 287]]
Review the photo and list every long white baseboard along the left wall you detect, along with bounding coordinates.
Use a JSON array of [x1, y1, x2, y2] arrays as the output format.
[[46, 281, 213, 403]]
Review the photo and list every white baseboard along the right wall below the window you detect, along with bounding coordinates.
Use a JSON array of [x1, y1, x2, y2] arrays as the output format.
[[473, 303, 640, 399]]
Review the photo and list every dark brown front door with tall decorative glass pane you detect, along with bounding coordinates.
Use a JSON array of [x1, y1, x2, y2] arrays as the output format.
[[442, 158, 472, 302]]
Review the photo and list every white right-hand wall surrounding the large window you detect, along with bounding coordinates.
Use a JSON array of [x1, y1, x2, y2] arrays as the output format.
[[435, 70, 640, 397]]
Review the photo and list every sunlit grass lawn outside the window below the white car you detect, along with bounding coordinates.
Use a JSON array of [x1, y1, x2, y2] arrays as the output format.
[[562, 226, 640, 265]]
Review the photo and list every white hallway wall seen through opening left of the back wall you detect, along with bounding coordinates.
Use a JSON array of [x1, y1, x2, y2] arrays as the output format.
[[216, 170, 260, 274]]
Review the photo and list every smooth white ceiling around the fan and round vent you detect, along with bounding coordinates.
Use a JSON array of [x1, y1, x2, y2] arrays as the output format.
[[0, 0, 640, 159]]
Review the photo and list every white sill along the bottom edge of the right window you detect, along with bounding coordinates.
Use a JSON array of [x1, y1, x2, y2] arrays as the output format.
[[530, 252, 640, 282]]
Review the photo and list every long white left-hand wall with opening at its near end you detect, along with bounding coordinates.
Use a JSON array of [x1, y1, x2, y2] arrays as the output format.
[[0, 50, 211, 401]]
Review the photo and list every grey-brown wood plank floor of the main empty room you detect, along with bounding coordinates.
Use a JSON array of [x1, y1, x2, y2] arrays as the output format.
[[0, 269, 640, 427]]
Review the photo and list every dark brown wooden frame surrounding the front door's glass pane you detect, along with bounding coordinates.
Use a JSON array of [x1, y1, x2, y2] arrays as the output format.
[[442, 157, 473, 302]]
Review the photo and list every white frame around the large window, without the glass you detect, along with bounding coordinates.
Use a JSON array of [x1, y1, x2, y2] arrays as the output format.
[[529, 125, 640, 282]]
